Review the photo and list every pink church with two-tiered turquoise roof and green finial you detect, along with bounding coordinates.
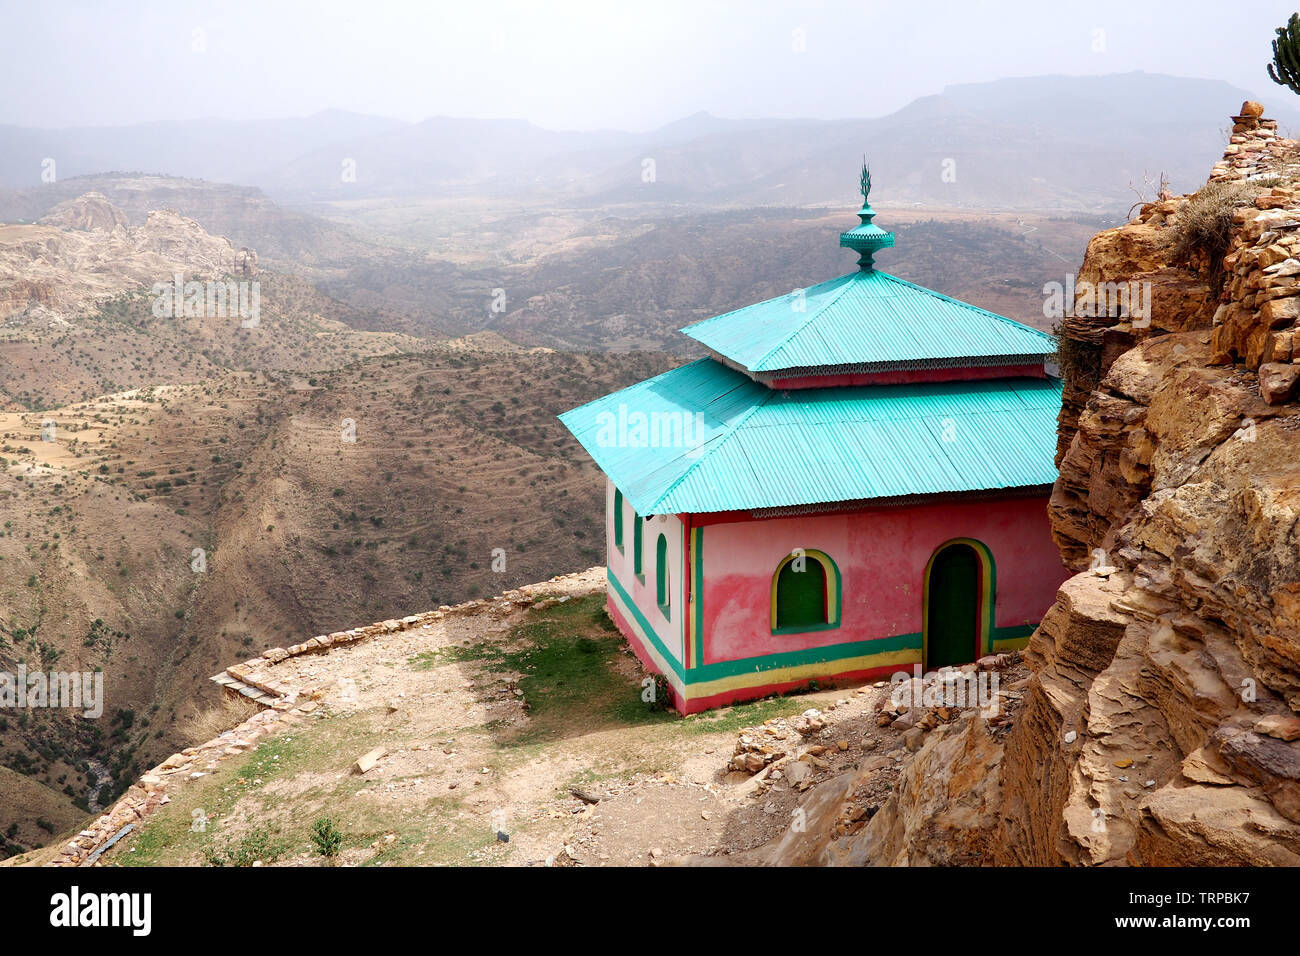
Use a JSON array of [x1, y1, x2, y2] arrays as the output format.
[[560, 169, 1067, 714]]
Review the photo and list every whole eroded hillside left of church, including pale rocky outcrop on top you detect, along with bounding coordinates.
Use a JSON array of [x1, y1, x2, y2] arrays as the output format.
[[0, 195, 671, 852]]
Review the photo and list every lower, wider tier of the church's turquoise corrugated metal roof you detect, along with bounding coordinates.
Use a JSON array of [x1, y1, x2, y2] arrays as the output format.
[[560, 359, 1061, 515]]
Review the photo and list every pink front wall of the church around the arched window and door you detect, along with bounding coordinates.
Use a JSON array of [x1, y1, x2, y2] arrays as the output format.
[[702, 496, 1069, 663]]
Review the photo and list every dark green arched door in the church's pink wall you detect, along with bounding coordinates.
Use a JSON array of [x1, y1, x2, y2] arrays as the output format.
[[922, 538, 993, 671]]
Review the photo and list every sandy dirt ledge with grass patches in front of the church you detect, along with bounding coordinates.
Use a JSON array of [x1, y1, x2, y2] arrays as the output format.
[[101, 568, 1008, 866]]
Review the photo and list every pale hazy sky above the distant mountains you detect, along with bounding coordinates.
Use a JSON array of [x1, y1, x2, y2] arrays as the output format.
[[0, 0, 1294, 130]]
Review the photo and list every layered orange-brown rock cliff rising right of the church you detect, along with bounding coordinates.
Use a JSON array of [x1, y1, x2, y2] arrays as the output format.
[[785, 104, 1300, 865]]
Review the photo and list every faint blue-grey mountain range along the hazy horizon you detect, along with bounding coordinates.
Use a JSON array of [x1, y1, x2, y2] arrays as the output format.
[[0, 72, 1300, 209]]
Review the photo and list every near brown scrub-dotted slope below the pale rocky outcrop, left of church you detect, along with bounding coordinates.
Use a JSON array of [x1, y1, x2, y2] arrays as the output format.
[[0, 345, 668, 853]]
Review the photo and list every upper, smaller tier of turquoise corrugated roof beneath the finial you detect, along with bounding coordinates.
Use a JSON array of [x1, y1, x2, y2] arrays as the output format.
[[683, 269, 1056, 373]]
